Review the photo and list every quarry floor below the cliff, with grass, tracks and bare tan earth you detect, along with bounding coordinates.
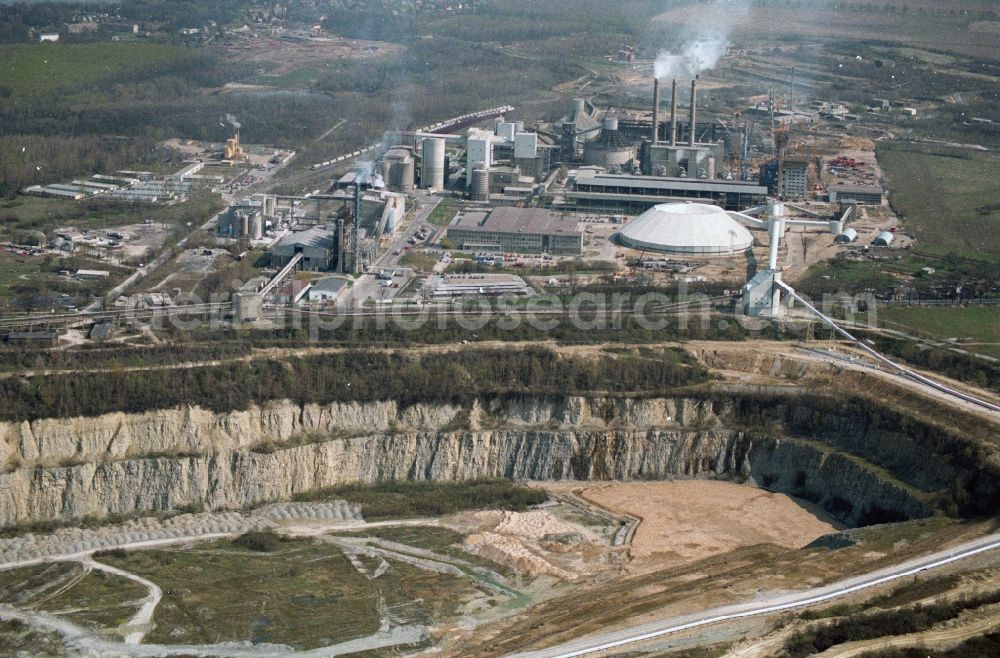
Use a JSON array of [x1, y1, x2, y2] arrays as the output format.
[[0, 480, 992, 656]]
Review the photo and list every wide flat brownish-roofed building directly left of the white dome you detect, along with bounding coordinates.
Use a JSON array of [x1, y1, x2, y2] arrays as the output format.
[[448, 207, 583, 256]]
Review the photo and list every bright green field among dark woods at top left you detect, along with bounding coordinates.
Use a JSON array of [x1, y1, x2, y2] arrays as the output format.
[[0, 41, 186, 96]]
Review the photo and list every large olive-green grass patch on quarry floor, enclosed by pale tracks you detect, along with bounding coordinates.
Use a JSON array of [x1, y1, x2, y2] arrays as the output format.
[[94, 529, 488, 649]]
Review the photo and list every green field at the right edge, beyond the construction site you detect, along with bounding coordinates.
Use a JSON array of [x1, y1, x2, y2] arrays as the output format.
[[877, 142, 1000, 263]]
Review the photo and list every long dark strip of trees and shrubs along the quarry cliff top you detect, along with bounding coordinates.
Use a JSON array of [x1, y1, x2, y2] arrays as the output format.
[[0, 347, 708, 421]]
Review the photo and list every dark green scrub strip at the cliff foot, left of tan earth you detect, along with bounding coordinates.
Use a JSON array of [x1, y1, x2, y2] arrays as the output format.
[[295, 480, 548, 520]]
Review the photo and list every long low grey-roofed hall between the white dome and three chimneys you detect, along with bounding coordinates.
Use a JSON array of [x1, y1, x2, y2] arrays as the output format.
[[564, 169, 767, 213]]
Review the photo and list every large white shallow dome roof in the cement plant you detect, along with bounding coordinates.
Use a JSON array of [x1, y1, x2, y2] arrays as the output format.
[[618, 203, 753, 256]]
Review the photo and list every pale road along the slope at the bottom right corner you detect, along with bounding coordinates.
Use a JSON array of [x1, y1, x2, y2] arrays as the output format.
[[516, 534, 1000, 658]]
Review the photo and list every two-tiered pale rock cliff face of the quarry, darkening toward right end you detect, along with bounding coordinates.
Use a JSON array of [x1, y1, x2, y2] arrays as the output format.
[[0, 397, 931, 525]]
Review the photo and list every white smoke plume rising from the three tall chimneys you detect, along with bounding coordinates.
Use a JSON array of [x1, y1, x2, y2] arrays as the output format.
[[653, 0, 750, 78]]
